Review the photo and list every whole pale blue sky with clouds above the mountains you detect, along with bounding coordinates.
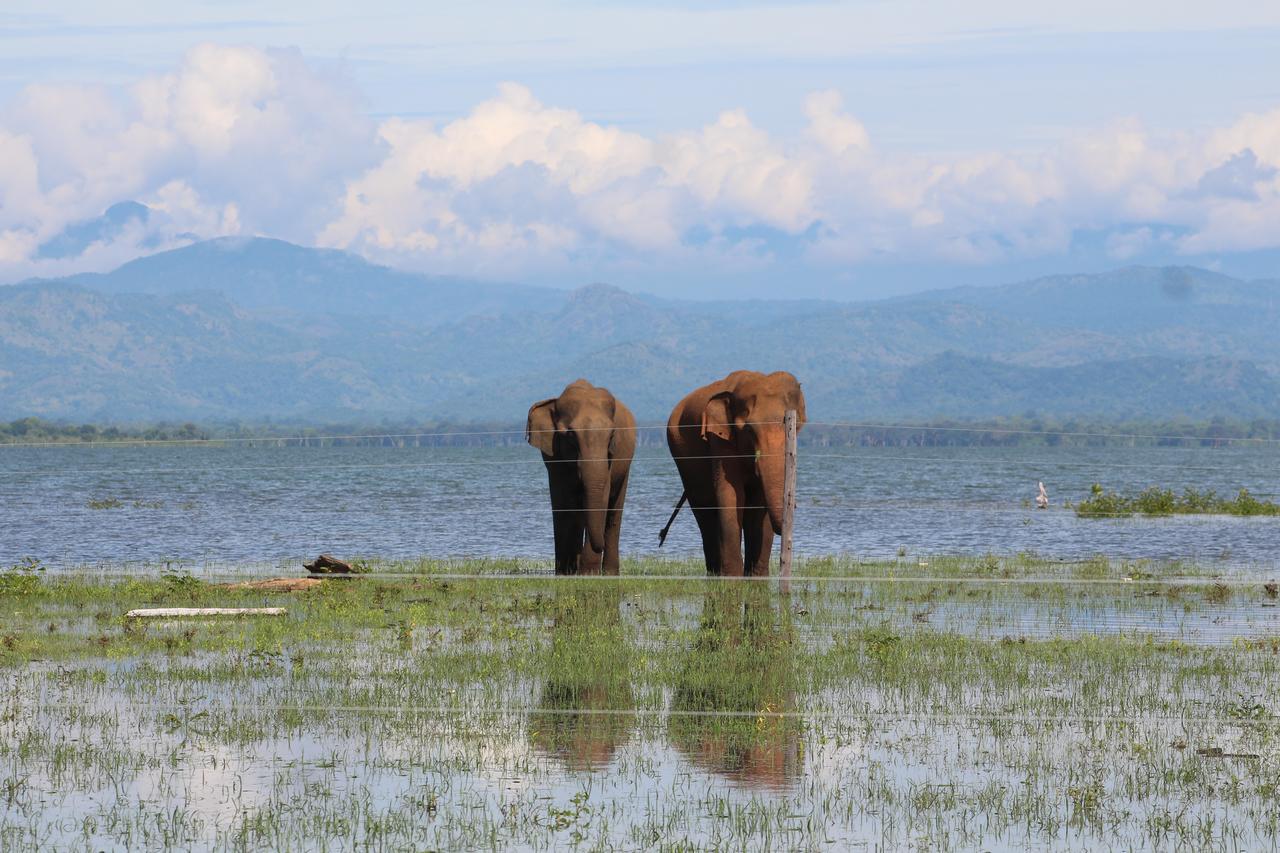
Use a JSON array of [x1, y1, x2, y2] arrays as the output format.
[[0, 0, 1280, 298]]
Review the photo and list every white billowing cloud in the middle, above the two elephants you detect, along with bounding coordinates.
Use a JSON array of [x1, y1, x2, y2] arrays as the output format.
[[319, 85, 815, 266]]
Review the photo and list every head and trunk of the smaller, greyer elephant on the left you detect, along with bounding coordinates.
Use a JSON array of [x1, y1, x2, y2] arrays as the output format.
[[525, 379, 624, 553]]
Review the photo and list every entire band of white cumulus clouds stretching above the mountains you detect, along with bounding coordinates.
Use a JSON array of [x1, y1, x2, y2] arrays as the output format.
[[0, 45, 1280, 281]]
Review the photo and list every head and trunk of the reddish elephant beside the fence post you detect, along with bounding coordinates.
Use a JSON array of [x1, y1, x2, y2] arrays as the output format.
[[701, 370, 805, 534]]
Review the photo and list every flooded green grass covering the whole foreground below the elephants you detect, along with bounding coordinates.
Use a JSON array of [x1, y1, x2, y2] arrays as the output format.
[[0, 556, 1280, 849]]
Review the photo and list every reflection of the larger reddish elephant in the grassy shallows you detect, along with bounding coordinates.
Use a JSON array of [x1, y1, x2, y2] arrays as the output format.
[[667, 585, 804, 788]]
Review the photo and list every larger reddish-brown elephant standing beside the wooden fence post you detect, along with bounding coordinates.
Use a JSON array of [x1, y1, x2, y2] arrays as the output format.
[[667, 370, 805, 578]]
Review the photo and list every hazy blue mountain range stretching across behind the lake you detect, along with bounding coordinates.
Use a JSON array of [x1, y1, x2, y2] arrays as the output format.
[[0, 238, 1280, 423]]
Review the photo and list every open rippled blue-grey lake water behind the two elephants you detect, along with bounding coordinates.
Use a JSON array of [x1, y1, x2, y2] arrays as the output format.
[[0, 444, 1280, 569]]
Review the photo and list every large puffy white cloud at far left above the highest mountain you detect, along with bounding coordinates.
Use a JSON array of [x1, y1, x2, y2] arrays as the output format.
[[0, 45, 381, 272]]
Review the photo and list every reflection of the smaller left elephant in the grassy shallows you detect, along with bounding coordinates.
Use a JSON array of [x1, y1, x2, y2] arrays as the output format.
[[529, 588, 635, 770]]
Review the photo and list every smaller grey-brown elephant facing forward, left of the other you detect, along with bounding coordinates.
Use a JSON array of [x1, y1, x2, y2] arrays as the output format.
[[525, 379, 636, 575]]
